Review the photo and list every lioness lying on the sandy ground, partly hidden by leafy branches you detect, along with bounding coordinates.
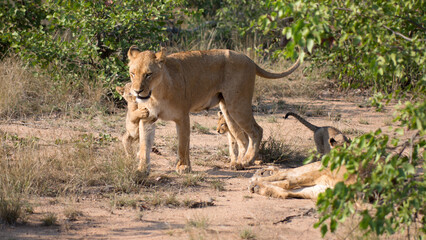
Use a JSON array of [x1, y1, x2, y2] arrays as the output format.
[[249, 162, 356, 200]]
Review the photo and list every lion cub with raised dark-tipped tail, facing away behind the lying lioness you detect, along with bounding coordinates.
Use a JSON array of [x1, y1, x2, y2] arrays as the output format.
[[284, 112, 350, 154]]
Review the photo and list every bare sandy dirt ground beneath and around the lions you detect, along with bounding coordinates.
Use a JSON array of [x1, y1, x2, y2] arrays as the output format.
[[0, 94, 404, 240]]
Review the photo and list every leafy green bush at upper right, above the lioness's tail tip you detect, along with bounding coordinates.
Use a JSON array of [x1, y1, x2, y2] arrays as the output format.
[[257, 0, 426, 93]]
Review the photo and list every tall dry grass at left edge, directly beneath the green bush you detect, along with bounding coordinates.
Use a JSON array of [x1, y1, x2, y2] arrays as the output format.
[[0, 56, 108, 119]]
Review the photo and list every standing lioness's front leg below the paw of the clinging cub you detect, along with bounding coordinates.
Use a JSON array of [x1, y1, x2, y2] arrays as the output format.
[[138, 120, 155, 175]]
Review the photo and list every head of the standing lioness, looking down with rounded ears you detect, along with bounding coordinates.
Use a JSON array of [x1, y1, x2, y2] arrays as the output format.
[[127, 46, 166, 102]]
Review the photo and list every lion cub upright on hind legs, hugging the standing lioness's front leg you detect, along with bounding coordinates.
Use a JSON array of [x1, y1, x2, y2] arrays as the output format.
[[116, 83, 149, 156]]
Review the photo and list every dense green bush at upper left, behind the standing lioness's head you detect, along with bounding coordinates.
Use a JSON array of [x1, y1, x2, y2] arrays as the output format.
[[0, 0, 190, 93]]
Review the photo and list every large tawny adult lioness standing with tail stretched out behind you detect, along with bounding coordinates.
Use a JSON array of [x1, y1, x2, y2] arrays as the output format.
[[127, 46, 300, 173]]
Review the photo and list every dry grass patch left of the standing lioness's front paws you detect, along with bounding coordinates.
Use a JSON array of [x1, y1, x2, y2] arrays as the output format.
[[0, 129, 144, 199]]
